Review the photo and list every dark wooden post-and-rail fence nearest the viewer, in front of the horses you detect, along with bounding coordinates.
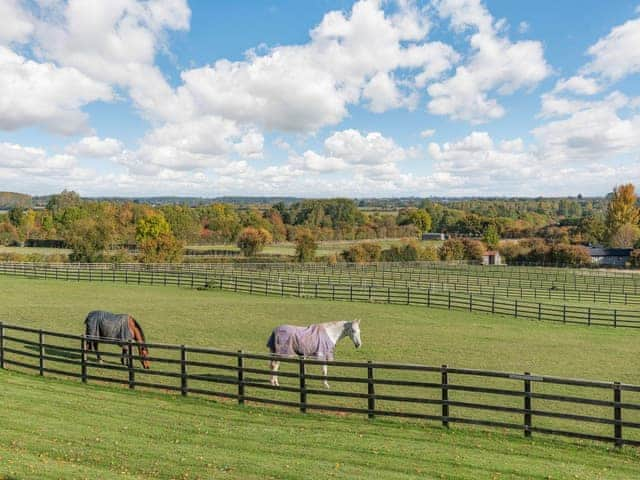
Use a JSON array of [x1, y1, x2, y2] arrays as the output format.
[[0, 323, 640, 446]]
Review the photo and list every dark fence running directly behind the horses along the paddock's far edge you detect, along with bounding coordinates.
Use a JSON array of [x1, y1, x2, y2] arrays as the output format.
[[0, 263, 640, 328]]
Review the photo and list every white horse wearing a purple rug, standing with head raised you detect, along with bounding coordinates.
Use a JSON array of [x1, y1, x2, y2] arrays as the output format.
[[267, 320, 362, 388]]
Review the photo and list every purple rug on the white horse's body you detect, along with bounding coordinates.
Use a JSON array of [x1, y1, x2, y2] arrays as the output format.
[[267, 325, 335, 360]]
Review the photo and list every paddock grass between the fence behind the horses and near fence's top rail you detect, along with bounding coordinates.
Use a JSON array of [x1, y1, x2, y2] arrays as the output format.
[[0, 276, 640, 383]]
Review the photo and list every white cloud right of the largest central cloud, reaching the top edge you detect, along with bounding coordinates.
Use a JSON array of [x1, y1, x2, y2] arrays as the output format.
[[427, 0, 551, 123]]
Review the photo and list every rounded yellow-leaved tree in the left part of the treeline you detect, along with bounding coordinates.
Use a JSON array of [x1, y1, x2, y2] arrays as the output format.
[[136, 213, 184, 263]]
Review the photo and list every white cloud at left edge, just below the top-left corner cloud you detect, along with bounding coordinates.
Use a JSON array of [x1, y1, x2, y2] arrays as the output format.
[[0, 46, 113, 134]]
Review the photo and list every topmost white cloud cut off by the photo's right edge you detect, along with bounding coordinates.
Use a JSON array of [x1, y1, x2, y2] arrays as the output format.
[[583, 18, 640, 81]]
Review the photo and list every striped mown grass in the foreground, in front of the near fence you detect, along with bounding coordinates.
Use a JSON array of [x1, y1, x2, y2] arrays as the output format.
[[0, 371, 640, 480]]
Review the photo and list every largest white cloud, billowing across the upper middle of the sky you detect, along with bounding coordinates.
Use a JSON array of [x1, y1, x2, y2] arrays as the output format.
[[172, 0, 458, 132]]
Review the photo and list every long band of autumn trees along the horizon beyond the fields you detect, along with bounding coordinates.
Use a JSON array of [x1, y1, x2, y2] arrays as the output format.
[[0, 184, 640, 264]]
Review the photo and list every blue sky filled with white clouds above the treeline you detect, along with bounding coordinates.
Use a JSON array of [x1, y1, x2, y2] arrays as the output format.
[[0, 0, 640, 198]]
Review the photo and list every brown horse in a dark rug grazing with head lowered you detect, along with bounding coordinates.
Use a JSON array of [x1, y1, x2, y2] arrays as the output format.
[[84, 311, 151, 368]]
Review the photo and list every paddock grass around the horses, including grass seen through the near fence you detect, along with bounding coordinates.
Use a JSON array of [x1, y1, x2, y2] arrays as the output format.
[[0, 276, 640, 448]]
